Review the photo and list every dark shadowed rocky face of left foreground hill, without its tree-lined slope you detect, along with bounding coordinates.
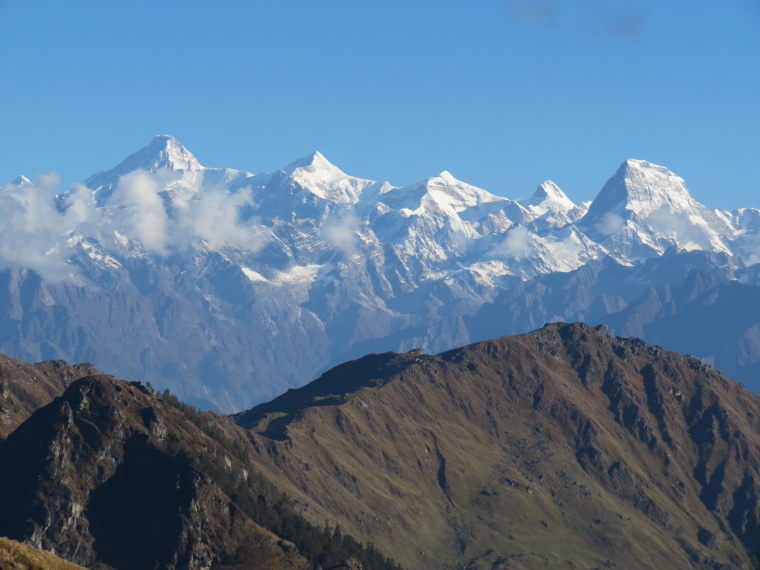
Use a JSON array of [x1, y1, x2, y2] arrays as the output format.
[[0, 376, 312, 570]]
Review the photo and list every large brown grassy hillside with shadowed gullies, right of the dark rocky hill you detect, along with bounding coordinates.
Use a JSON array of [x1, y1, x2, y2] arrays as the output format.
[[242, 324, 760, 569]]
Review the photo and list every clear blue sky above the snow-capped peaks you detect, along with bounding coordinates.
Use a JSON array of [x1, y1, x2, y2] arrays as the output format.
[[0, 0, 760, 208]]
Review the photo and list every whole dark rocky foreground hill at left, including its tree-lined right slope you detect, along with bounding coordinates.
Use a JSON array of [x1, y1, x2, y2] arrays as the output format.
[[0, 374, 398, 570]]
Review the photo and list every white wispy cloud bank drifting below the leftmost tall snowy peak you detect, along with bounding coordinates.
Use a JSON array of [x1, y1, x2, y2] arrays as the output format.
[[0, 165, 272, 281]]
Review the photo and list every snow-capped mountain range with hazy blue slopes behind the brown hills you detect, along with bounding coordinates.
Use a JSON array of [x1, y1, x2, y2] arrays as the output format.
[[0, 135, 760, 411]]
